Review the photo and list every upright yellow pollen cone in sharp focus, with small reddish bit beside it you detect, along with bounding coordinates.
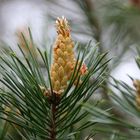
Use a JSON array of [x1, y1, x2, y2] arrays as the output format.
[[51, 17, 87, 95]]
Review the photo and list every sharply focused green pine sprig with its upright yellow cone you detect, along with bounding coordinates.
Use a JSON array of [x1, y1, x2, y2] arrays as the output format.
[[0, 17, 109, 140]]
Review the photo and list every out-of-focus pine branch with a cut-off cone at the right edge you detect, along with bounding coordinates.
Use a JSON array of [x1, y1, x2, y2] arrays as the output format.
[[84, 45, 140, 140]]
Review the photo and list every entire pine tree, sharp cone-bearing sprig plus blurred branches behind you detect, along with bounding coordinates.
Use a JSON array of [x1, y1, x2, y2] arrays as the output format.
[[0, 0, 140, 140]]
